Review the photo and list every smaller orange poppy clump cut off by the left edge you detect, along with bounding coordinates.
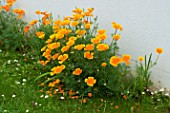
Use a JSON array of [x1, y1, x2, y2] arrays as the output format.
[[0, 0, 32, 53]]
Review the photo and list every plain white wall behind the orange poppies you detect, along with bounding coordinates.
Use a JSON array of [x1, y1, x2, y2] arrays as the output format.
[[15, 0, 170, 88]]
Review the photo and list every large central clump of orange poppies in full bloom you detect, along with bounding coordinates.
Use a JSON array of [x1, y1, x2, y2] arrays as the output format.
[[32, 8, 161, 98]]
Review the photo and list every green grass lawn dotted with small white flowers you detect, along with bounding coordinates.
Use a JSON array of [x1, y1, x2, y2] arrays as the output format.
[[0, 51, 170, 113]]
